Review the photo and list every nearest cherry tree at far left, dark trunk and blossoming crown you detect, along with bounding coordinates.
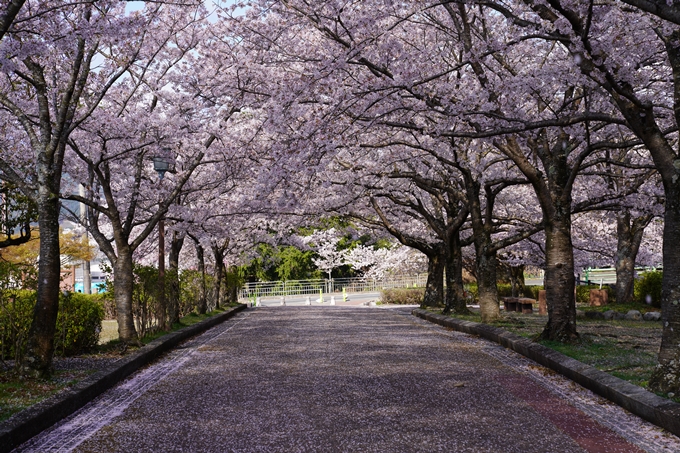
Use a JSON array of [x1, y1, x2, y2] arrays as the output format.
[[0, 1, 202, 376]]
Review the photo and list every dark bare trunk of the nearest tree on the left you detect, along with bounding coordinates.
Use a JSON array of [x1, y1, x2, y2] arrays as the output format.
[[22, 191, 61, 378]]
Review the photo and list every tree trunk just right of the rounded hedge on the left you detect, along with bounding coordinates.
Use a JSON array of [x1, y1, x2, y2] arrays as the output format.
[[113, 249, 139, 344]]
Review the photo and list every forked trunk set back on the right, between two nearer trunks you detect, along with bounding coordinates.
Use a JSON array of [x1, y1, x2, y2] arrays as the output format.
[[614, 210, 652, 304]]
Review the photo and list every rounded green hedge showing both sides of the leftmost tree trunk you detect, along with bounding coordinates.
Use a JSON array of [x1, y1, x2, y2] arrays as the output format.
[[0, 290, 104, 360]]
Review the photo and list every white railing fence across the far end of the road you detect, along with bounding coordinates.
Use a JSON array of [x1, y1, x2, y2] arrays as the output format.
[[239, 274, 427, 299]]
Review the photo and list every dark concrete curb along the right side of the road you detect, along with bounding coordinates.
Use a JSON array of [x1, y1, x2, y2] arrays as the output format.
[[411, 309, 680, 436]]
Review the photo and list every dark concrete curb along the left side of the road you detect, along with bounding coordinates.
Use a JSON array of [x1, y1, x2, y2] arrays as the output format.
[[0, 304, 246, 453]]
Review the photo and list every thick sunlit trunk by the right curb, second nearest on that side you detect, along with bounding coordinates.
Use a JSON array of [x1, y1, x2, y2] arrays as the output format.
[[540, 217, 578, 342]]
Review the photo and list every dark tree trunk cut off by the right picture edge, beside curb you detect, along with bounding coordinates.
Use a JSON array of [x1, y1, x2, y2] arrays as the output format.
[[649, 185, 680, 394]]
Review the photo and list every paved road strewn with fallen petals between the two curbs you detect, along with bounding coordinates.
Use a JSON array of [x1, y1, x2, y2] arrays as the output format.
[[17, 307, 680, 453]]
